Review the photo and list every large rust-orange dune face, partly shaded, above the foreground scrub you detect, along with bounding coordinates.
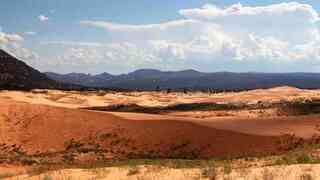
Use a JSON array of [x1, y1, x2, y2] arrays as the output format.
[[0, 97, 276, 157]]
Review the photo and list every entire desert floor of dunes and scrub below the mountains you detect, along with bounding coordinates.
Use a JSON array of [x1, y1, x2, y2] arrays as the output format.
[[0, 87, 320, 179]]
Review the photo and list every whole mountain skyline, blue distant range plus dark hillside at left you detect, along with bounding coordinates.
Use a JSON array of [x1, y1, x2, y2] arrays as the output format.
[[5, 45, 320, 90]]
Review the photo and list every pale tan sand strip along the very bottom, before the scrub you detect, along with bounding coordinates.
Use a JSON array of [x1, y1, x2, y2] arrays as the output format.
[[8, 165, 320, 180]]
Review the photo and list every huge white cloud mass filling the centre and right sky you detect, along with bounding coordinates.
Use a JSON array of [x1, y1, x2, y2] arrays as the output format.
[[44, 2, 320, 71]]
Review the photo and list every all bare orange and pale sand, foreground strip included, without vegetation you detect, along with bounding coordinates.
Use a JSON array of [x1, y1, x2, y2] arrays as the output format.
[[0, 87, 320, 180]]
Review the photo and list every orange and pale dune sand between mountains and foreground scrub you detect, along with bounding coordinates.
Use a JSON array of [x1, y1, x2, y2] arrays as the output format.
[[0, 87, 319, 157]]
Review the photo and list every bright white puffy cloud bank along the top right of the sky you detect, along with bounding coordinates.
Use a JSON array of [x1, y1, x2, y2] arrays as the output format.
[[179, 2, 319, 23]]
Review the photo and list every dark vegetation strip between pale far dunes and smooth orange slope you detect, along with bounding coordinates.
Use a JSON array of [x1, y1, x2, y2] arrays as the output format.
[[83, 100, 320, 116]]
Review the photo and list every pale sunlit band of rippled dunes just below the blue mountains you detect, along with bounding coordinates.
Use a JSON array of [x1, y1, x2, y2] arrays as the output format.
[[0, 87, 320, 108]]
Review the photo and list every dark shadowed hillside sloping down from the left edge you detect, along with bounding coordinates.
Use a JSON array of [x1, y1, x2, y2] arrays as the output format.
[[0, 49, 78, 90]]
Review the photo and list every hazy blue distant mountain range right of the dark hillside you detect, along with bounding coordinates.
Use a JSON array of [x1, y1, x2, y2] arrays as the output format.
[[46, 69, 320, 90]]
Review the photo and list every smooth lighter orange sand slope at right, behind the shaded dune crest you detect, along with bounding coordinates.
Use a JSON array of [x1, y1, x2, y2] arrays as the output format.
[[106, 112, 320, 138]]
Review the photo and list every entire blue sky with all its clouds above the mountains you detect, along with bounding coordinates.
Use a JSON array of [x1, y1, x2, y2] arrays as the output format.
[[0, 0, 320, 74]]
